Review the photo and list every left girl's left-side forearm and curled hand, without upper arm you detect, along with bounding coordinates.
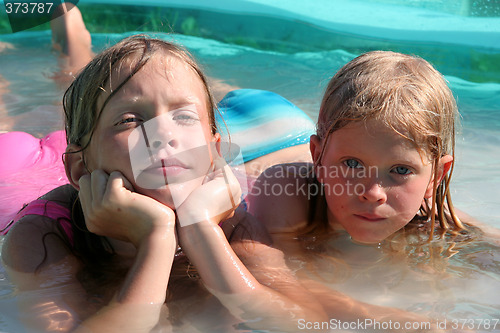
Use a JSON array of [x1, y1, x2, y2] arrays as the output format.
[[75, 170, 177, 332]]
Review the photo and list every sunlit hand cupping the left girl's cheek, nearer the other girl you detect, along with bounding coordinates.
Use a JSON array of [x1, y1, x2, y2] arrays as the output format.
[[177, 157, 241, 227]]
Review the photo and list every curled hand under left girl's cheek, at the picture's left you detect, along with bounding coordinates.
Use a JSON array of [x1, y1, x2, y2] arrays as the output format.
[[79, 170, 175, 247]]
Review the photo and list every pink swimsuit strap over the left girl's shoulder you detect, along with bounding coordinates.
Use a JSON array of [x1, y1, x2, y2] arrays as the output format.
[[1, 199, 73, 246]]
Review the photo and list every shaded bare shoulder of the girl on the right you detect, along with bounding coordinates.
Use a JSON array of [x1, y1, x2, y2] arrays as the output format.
[[247, 163, 311, 233]]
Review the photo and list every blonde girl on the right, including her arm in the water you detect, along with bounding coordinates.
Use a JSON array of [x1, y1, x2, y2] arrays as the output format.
[[243, 51, 500, 324]]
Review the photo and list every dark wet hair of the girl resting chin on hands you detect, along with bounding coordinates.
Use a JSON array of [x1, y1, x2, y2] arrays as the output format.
[[63, 35, 218, 291]]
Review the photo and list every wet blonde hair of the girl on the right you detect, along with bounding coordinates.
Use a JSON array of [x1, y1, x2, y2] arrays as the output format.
[[309, 51, 464, 238]]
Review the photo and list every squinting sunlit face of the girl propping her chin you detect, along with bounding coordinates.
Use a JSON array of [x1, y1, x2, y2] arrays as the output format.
[[85, 55, 220, 209]]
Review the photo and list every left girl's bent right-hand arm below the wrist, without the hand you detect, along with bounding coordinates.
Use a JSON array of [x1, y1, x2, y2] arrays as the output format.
[[178, 213, 326, 332]]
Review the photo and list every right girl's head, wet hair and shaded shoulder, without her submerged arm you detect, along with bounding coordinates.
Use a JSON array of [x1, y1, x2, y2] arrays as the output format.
[[250, 51, 465, 244]]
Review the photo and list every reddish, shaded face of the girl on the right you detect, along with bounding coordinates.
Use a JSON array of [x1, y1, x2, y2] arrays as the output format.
[[311, 120, 451, 243]]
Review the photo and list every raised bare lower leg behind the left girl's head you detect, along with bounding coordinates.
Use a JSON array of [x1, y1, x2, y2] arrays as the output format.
[[50, 2, 94, 75]]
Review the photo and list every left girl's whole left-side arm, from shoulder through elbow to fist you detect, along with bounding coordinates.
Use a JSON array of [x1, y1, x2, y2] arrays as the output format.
[[2, 171, 176, 332]]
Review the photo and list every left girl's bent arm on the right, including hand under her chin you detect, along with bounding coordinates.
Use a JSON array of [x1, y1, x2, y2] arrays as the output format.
[[177, 160, 325, 332]]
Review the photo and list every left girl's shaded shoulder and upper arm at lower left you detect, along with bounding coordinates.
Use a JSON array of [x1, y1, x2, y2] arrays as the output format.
[[1, 184, 93, 332]]
